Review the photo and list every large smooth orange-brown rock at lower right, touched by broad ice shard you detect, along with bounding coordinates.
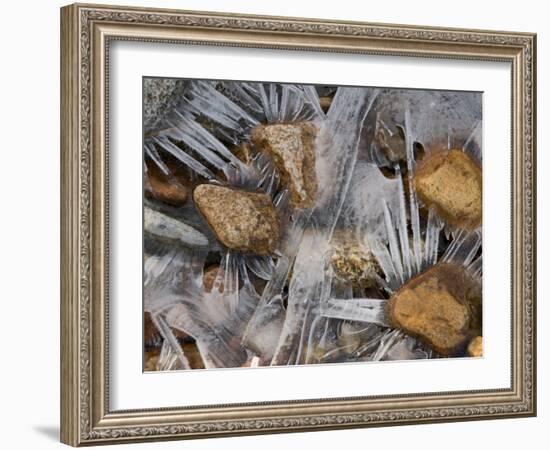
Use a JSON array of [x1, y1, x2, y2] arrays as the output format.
[[388, 263, 481, 355]]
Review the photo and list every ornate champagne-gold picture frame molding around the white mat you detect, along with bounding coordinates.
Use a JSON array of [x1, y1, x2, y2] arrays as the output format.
[[61, 4, 536, 446]]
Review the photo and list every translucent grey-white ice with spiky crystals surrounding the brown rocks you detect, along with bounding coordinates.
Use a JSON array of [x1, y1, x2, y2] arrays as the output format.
[[144, 81, 482, 370]]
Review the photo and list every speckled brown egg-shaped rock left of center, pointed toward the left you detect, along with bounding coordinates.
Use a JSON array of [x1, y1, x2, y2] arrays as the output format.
[[193, 184, 280, 255]]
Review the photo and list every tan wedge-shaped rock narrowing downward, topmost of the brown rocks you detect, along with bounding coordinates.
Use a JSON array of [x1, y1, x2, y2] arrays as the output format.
[[252, 122, 317, 209]]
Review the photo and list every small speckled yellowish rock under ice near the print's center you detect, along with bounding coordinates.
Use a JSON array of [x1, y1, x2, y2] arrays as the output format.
[[331, 232, 380, 288]]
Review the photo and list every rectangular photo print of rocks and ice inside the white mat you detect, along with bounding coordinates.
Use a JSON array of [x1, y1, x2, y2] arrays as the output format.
[[143, 79, 482, 371]]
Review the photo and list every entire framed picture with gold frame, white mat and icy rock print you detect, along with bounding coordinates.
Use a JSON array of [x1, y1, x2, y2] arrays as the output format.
[[61, 4, 536, 446]]
